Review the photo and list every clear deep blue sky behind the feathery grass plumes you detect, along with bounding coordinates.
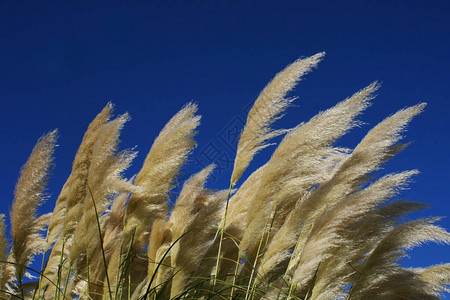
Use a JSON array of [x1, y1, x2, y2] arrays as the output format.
[[0, 0, 450, 290]]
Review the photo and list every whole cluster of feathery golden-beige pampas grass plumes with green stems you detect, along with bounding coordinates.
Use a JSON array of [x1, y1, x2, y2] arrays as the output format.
[[0, 53, 450, 299]]
